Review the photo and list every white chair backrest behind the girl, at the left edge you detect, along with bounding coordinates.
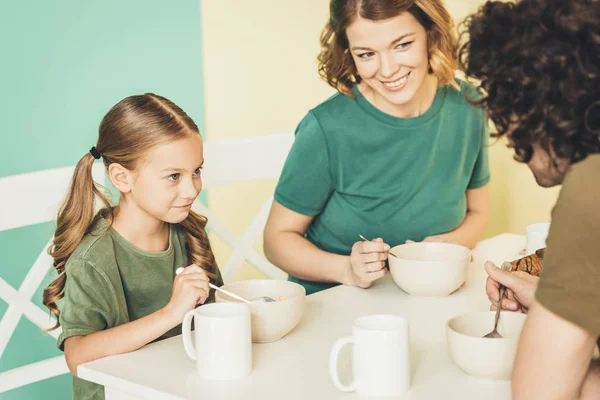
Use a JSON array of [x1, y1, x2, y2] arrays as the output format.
[[0, 163, 104, 393]]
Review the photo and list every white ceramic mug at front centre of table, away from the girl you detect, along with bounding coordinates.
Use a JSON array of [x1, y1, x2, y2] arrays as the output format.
[[329, 315, 411, 396]]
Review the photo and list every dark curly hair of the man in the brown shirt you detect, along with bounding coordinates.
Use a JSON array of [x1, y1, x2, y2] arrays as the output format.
[[459, 0, 600, 163]]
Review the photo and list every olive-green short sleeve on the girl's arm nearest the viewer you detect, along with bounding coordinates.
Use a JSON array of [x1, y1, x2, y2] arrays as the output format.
[[57, 260, 117, 350]]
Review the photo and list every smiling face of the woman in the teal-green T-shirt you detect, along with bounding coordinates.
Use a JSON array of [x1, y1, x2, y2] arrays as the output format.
[[346, 12, 429, 111]]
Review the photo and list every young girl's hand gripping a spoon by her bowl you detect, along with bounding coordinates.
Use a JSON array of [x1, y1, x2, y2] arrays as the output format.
[[165, 264, 210, 323]]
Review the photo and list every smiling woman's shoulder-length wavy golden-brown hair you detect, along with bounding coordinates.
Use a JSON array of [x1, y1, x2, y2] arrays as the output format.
[[318, 0, 459, 97]]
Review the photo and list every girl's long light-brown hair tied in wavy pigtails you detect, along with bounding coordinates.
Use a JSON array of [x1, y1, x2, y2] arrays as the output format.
[[43, 93, 218, 330]]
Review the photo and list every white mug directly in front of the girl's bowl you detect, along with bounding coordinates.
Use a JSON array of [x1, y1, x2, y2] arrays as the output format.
[[181, 303, 252, 380]]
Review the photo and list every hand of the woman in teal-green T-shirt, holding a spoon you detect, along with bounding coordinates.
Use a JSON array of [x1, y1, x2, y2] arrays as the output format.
[[346, 238, 390, 288]]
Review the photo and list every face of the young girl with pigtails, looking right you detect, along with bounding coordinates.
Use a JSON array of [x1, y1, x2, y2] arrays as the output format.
[[126, 134, 204, 223]]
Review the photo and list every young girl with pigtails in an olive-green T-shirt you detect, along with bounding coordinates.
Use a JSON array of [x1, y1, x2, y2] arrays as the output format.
[[44, 93, 223, 399]]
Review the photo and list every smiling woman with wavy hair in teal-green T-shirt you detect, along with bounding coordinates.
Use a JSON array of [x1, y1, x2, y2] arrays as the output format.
[[264, 0, 490, 294]]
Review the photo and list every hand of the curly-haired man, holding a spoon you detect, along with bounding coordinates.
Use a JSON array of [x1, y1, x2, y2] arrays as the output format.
[[485, 261, 540, 313]]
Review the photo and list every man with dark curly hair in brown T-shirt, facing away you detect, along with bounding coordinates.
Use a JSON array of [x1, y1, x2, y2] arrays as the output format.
[[460, 0, 600, 400]]
